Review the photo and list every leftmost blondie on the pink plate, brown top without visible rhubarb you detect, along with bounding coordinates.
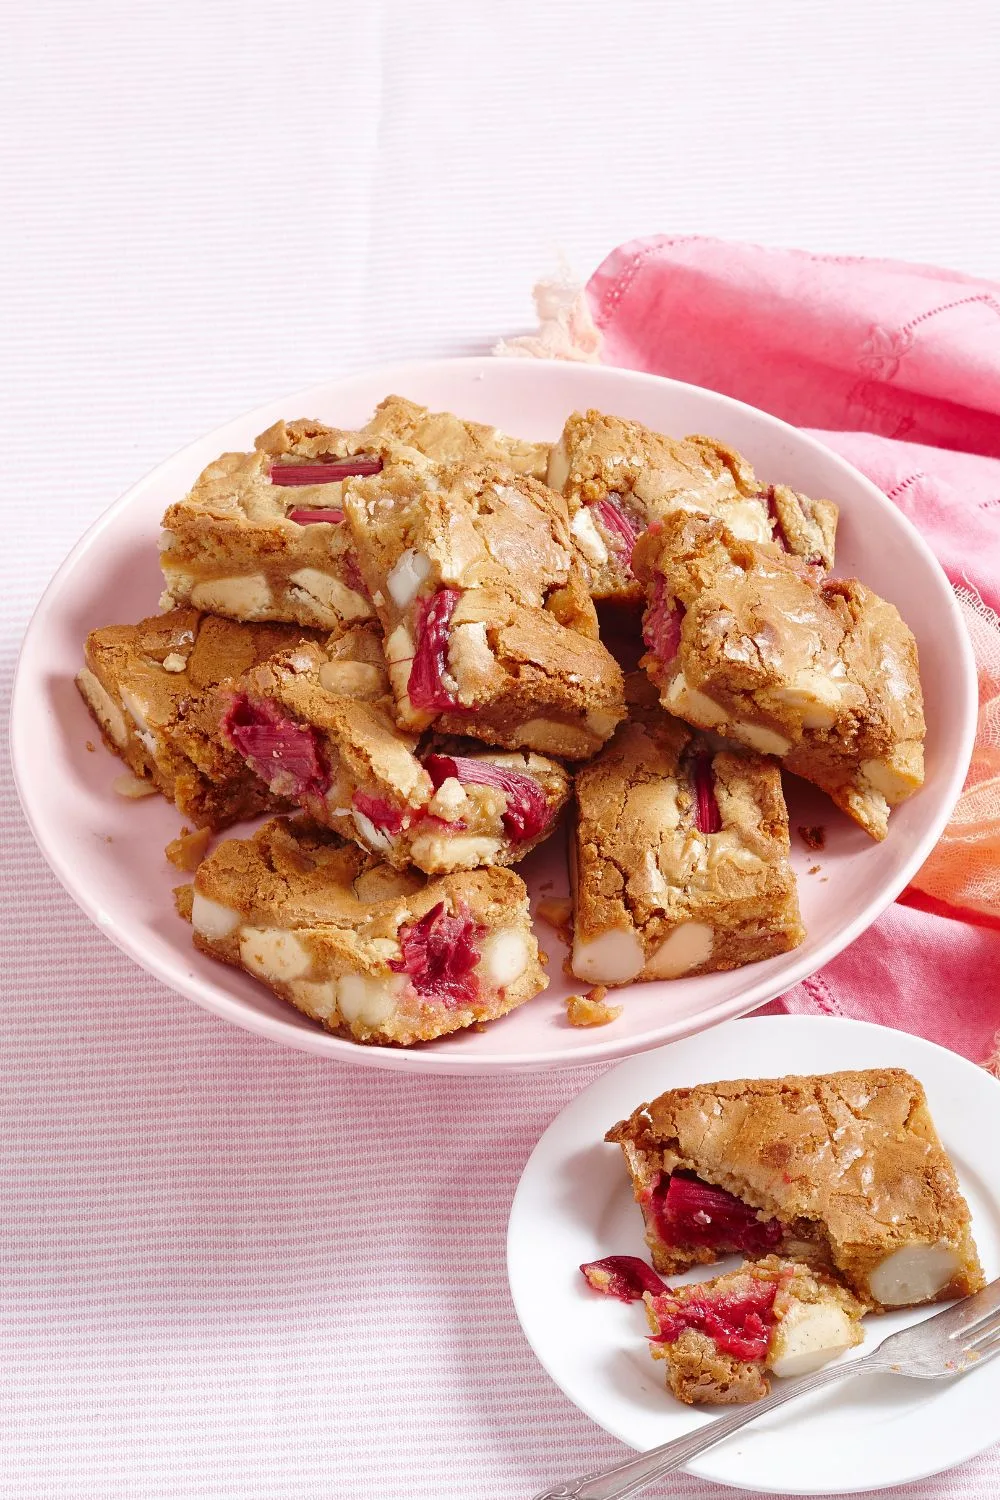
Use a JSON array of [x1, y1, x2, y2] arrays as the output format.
[[76, 609, 316, 828]]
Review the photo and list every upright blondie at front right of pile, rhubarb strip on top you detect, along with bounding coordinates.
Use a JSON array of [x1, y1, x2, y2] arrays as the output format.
[[571, 708, 805, 984]]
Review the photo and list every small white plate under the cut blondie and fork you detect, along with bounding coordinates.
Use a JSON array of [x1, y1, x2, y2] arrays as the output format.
[[507, 1016, 1000, 1496]]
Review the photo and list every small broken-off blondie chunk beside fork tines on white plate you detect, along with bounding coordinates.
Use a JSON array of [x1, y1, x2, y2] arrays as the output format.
[[645, 1256, 865, 1406]]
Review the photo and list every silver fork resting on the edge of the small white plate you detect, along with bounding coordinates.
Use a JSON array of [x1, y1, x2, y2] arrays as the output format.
[[535, 1280, 1000, 1500]]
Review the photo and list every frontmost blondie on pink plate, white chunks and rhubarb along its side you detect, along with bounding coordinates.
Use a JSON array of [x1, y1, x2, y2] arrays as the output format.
[[178, 819, 547, 1047]]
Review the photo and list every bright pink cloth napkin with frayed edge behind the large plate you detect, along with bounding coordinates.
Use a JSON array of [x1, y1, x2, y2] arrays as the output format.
[[587, 236, 1000, 1067]]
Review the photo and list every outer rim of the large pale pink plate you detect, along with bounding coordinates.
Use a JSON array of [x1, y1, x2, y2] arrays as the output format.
[[9, 356, 978, 1073]]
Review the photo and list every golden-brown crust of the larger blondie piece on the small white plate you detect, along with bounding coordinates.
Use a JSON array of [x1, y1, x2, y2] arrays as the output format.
[[606, 1068, 982, 1305]]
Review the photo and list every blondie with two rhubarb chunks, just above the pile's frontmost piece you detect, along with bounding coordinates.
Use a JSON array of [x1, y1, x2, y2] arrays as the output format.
[[220, 629, 570, 875]]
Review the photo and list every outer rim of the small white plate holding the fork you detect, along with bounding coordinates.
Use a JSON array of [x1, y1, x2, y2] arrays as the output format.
[[507, 1016, 1000, 1496]]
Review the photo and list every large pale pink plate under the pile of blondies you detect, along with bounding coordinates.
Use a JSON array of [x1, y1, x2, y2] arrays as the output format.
[[10, 359, 976, 1073]]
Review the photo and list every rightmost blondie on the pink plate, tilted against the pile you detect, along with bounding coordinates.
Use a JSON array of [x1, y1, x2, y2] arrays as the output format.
[[634, 513, 925, 839]]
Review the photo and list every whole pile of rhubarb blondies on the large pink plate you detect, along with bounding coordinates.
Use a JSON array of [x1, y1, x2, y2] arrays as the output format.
[[78, 396, 924, 1044]]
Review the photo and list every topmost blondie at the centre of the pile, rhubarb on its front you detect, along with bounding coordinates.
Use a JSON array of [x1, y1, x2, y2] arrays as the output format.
[[343, 465, 625, 759]]
